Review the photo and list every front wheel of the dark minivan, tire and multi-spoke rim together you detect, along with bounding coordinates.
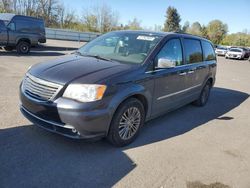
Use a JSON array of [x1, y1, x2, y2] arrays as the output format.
[[107, 98, 145, 147]]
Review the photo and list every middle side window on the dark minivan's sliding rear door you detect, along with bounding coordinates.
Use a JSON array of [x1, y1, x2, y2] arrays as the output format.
[[184, 39, 202, 64]]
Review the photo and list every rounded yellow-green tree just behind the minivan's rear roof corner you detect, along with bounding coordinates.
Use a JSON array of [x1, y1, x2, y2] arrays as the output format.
[[207, 20, 228, 44]]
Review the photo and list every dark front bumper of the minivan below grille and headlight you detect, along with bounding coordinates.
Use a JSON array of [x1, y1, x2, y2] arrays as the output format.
[[20, 91, 111, 139]]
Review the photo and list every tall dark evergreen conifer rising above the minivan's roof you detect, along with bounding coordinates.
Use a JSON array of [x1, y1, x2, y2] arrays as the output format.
[[164, 6, 181, 32]]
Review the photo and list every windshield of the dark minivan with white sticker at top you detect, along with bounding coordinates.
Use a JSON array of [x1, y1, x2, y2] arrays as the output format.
[[78, 32, 162, 64]]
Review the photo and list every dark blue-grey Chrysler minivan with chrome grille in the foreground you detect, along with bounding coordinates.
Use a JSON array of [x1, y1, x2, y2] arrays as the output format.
[[20, 31, 216, 146]]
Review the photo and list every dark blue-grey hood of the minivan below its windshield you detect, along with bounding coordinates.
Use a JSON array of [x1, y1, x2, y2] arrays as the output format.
[[29, 55, 133, 85]]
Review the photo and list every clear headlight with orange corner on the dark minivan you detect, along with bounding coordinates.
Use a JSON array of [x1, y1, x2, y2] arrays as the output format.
[[63, 84, 107, 102]]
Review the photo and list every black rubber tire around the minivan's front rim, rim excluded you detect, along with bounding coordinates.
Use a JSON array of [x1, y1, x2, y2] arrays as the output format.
[[108, 98, 145, 147]]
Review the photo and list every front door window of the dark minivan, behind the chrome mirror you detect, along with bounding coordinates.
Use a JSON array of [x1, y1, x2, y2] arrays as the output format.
[[157, 39, 183, 66]]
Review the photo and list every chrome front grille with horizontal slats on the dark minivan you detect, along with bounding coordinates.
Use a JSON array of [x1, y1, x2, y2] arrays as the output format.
[[22, 73, 62, 101]]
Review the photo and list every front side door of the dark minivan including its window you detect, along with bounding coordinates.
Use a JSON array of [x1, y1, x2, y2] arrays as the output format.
[[152, 38, 189, 116]]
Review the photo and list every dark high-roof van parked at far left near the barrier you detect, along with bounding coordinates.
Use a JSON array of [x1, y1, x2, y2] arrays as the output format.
[[0, 13, 46, 54]]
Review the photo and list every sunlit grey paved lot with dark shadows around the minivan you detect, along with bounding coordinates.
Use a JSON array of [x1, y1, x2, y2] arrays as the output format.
[[0, 40, 250, 188]]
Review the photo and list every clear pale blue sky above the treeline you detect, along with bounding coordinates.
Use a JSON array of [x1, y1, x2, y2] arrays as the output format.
[[59, 0, 250, 33]]
